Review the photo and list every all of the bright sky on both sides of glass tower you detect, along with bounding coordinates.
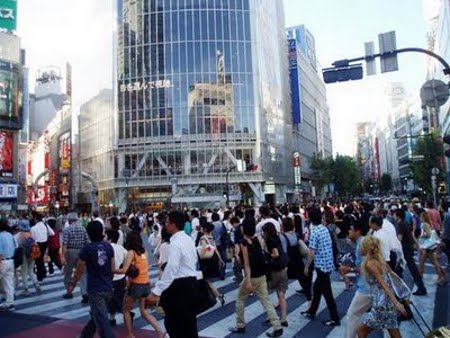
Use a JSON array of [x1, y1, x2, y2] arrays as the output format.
[[18, 0, 430, 155]]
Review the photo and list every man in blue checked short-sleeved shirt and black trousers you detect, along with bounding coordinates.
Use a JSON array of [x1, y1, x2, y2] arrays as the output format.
[[302, 209, 341, 326]]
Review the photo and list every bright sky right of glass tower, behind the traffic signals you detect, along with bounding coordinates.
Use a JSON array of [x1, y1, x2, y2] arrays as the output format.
[[284, 0, 427, 155]]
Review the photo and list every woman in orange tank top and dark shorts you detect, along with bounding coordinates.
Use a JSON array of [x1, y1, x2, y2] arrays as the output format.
[[114, 231, 165, 338]]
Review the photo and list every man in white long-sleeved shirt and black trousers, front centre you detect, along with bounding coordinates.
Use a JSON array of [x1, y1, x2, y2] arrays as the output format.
[[147, 211, 198, 338]]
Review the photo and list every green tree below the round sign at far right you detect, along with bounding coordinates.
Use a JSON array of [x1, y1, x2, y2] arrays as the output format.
[[411, 132, 445, 195]]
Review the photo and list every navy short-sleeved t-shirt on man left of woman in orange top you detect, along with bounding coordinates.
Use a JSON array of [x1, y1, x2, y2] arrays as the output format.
[[80, 242, 114, 293]]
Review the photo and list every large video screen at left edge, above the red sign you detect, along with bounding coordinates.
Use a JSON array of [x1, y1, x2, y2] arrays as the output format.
[[0, 60, 22, 129]]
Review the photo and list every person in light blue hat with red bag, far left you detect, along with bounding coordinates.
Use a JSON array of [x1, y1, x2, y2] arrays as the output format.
[[15, 219, 42, 296]]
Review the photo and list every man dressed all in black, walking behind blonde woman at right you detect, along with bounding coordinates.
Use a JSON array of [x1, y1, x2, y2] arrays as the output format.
[[395, 209, 427, 296]]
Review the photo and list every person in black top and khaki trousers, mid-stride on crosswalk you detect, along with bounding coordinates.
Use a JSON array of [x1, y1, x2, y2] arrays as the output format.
[[229, 219, 283, 337]]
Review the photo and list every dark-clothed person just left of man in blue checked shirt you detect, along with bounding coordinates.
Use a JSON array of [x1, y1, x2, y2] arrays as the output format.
[[280, 217, 312, 302]]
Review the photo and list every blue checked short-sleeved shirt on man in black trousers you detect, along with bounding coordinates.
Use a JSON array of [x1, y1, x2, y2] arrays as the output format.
[[309, 224, 334, 272]]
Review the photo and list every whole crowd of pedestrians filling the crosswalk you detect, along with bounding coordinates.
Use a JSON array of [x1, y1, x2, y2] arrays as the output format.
[[0, 199, 450, 338]]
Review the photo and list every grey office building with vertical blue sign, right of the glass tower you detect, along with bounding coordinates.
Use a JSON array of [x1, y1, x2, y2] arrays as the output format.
[[287, 25, 333, 197]]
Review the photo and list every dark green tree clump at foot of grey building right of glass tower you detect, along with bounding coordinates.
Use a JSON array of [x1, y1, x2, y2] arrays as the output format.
[[311, 155, 361, 196]]
